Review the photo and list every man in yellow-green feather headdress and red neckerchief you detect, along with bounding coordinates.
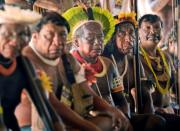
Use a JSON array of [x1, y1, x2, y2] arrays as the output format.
[[64, 4, 129, 114]]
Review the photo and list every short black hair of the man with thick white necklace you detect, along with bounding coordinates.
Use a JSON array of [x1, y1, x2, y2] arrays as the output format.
[[33, 12, 70, 32]]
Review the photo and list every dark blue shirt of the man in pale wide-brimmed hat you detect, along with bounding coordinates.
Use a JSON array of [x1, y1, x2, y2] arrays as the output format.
[[0, 56, 28, 131]]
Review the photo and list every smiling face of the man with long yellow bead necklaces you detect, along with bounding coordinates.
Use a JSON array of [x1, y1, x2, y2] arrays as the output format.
[[139, 21, 161, 48]]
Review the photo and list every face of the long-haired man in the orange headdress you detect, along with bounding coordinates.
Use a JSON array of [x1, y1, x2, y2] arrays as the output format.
[[115, 23, 135, 54]]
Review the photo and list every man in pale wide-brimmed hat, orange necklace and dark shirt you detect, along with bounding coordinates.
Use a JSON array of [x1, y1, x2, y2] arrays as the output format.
[[0, 6, 63, 131]]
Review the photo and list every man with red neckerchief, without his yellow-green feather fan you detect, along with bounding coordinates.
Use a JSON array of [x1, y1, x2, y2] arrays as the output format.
[[72, 21, 128, 114]]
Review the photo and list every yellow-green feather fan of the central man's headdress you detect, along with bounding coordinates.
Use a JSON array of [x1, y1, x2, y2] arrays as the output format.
[[63, 7, 115, 44]]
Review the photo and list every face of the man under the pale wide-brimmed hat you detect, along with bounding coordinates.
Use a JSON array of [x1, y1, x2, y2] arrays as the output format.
[[0, 24, 28, 59]]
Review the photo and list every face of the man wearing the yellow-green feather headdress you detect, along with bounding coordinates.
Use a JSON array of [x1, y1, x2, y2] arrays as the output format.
[[77, 23, 104, 58]]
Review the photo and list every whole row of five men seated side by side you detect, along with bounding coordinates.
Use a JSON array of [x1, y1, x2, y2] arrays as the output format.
[[0, 3, 180, 131]]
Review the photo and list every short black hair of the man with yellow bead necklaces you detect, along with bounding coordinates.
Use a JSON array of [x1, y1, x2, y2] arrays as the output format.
[[139, 14, 163, 28]]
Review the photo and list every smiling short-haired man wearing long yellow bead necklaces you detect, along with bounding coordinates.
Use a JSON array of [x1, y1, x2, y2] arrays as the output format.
[[139, 14, 180, 130]]
